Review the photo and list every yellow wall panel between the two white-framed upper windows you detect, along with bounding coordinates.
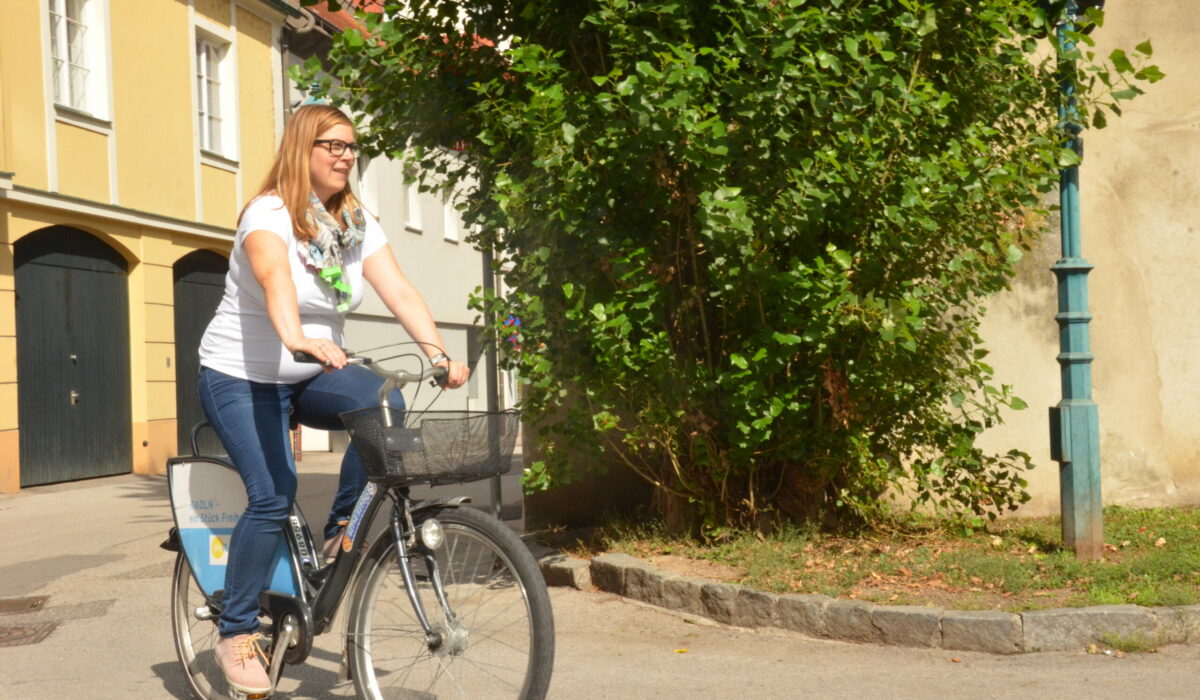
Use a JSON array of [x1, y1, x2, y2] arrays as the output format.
[[109, 2, 197, 220]]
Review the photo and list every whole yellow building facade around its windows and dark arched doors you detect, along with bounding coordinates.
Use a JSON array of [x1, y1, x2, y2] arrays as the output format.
[[0, 0, 281, 492]]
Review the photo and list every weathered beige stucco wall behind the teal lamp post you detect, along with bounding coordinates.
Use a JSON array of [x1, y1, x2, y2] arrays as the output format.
[[984, 0, 1200, 514]]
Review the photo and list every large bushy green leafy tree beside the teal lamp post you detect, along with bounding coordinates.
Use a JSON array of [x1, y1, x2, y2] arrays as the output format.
[[298, 0, 1160, 527]]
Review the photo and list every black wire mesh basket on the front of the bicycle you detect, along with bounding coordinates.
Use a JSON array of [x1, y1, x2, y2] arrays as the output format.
[[342, 407, 521, 486]]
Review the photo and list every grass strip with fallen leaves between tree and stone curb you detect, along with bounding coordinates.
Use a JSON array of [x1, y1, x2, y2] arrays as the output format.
[[545, 507, 1200, 614]]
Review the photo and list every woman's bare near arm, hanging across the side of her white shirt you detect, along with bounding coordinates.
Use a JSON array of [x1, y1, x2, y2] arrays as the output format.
[[241, 231, 346, 369]]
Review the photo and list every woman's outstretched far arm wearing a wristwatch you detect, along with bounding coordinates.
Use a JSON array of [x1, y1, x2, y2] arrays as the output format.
[[362, 245, 470, 389]]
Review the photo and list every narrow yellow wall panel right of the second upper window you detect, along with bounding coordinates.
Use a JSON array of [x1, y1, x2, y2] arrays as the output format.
[[237, 10, 277, 200]]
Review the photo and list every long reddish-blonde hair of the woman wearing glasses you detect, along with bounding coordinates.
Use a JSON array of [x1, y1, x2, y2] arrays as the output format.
[[238, 104, 358, 240]]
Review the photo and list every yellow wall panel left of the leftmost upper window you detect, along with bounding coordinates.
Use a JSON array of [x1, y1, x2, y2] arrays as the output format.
[[0, 1, 49, 190]]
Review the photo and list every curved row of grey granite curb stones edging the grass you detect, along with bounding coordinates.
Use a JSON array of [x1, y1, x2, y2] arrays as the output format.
[[530, 545, 1200, 654]]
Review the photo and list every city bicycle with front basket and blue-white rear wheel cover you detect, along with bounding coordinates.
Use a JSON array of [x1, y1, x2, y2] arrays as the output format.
[[163, 353, 554, 700]]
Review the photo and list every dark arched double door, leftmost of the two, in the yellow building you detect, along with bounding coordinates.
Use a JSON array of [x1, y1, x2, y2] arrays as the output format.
[[13, 226, 133, 486]]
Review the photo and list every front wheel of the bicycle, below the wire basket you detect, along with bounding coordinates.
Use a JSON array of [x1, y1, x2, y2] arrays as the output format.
[[347, 507, 554, 700]]
